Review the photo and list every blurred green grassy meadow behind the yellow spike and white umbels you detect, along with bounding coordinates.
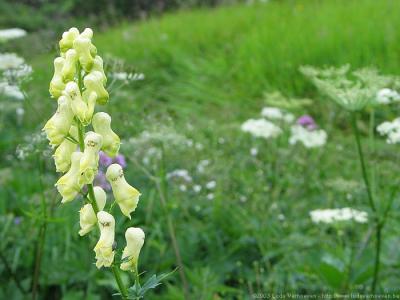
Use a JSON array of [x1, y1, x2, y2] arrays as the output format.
[[0, 0, 400, 299]]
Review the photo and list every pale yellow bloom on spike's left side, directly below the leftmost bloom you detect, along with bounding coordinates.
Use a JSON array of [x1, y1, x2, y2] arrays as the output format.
[[53, 126, 78, 173]]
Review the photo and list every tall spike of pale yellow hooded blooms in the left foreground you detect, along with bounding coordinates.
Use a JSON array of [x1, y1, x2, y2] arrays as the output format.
[[43, 28, 144, 272]]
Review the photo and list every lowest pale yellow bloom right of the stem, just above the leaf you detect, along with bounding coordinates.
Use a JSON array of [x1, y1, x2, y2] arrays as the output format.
[[121, 227, 145, 272]]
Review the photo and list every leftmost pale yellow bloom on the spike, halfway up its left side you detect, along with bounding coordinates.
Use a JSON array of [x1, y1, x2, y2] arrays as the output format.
[[42, 96, 74, 147]]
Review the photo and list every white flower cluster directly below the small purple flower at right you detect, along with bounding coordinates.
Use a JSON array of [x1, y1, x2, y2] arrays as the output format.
[[289, 125, 328, 148]]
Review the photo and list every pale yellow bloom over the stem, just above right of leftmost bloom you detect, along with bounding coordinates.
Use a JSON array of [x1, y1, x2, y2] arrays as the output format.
[[63, 81, 94, 125]]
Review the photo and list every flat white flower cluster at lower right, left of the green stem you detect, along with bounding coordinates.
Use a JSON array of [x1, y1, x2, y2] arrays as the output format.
[[310, 207, 368, 224]]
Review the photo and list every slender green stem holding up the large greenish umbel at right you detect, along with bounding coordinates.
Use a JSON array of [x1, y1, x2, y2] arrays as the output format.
[[352, 113, 383, 293]]
